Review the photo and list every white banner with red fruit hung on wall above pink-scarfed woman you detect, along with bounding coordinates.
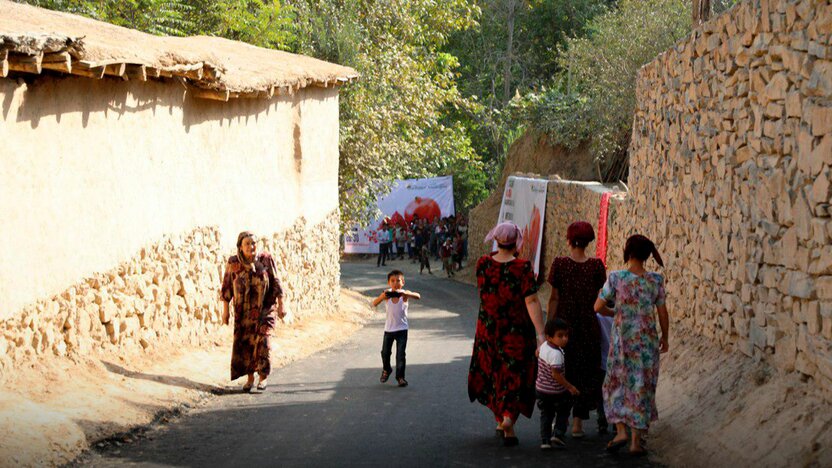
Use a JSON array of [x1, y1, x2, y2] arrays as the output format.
[[493, 176, 549, 275]]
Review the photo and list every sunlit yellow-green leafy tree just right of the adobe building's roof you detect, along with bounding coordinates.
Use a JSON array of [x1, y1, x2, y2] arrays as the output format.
[[288, 0, 485, 227]]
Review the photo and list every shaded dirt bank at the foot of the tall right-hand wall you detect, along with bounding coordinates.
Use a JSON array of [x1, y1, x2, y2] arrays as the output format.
[[455, 267, 832, 467]]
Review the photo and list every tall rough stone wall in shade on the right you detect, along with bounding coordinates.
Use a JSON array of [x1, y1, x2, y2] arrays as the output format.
[[626, 0, 832, 388]]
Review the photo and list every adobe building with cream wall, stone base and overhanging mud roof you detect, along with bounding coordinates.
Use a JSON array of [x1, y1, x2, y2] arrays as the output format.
[[0, 0, 357, 377]]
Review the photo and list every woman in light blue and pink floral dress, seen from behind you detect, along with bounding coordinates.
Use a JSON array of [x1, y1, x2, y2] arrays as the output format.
[[595, 235, 668, 455]]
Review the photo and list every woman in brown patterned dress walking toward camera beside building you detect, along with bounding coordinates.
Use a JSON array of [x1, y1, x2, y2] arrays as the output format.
[[220, 231, 285, 392]]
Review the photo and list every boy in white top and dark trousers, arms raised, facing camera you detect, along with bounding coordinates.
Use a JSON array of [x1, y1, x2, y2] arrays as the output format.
[[373, 270, 422, 387]]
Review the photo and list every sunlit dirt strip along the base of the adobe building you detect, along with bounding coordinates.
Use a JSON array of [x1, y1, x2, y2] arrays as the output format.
[[0, 289, 371, 466]]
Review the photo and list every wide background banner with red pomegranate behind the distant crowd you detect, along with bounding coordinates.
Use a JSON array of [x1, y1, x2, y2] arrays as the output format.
[[344, 176, 455, 254]]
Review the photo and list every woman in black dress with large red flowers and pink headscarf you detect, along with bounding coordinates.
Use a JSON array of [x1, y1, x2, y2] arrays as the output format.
[[468, 222, 543, 446]]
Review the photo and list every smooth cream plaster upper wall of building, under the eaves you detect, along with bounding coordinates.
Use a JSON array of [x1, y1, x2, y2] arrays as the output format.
[[0, 76, 338, 319]]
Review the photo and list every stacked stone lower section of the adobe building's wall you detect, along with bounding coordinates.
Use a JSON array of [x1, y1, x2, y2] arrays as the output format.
[[0, 211, 340, 376]]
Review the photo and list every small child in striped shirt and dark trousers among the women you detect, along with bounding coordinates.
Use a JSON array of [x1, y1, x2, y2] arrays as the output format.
[[535, 318, 580, 450]]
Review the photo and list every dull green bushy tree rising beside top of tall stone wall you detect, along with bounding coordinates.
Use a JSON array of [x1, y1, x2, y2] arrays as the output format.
[[515, 0, 691, 180]]
